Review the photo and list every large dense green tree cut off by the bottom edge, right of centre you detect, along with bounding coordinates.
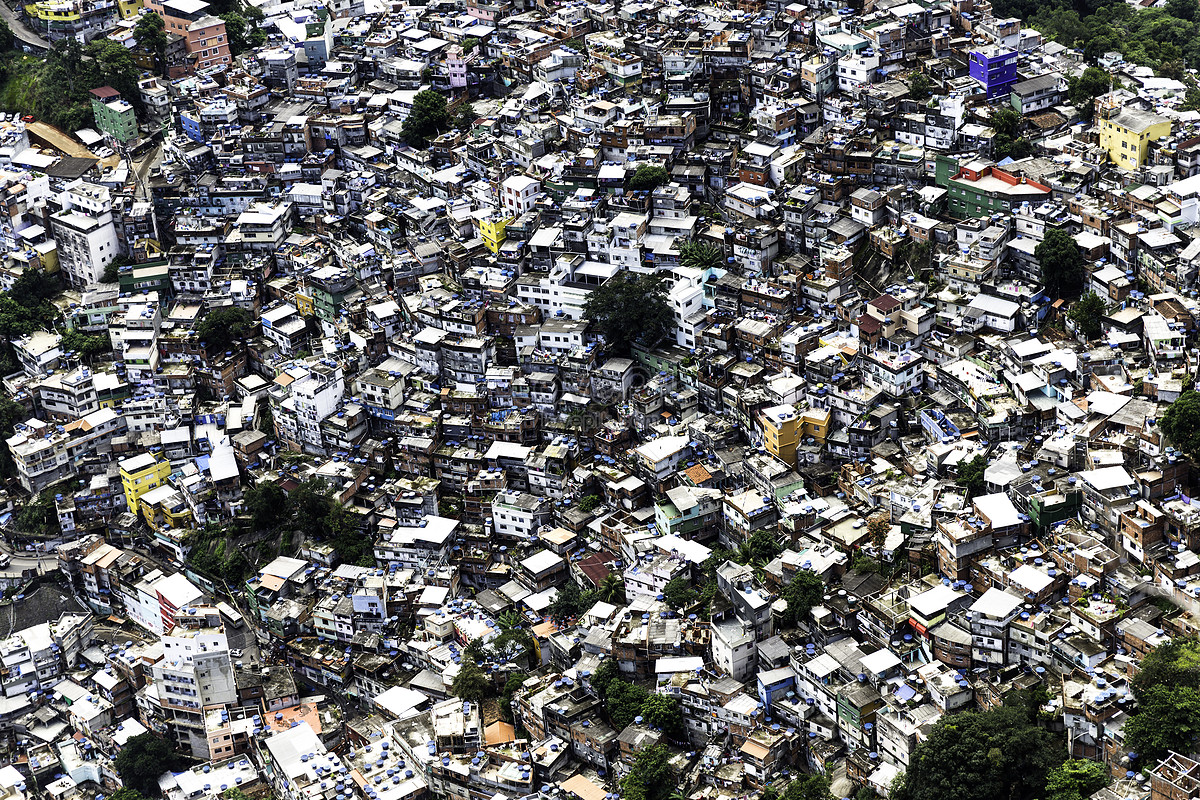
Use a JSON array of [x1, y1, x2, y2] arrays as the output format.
[[889, 708, 1064, 800]]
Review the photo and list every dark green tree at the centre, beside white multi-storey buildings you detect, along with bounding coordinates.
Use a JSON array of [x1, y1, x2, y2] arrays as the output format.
[[583, 272, 674, 355]]
